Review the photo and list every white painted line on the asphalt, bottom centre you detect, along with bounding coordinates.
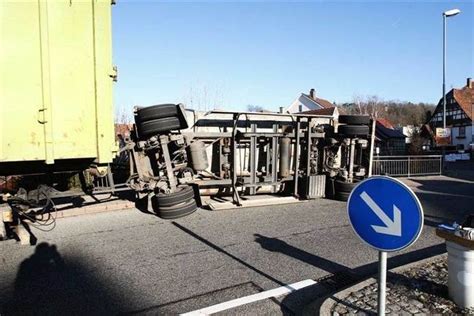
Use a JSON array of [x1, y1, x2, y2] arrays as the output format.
[[181, 279, 316, 316]]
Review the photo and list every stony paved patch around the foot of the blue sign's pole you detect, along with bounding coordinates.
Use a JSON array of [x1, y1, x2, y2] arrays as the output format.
[[331, 255, 474, 315]]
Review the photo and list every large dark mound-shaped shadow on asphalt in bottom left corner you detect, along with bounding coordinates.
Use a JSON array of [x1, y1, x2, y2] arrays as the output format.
[[0, 243, 130, 315]]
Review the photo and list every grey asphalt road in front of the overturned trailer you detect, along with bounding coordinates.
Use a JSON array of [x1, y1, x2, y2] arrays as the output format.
[[0, 177, 468, 315]]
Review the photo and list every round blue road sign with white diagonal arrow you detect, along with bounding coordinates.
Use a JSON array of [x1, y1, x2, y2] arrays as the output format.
[[347, 176, 423, 251]]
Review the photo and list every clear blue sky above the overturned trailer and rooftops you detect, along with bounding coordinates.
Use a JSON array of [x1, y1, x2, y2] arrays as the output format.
[[112, 0, 474, 111]]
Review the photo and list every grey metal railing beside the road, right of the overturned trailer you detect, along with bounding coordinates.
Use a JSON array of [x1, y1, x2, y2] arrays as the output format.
[[372, 155, 443, 177]]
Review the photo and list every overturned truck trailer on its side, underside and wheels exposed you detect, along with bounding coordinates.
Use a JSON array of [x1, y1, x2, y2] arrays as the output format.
[[124, 104, 373, 219]]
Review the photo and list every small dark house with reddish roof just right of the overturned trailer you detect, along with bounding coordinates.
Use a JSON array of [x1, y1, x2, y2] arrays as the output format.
[[375, 118, 406, 155]]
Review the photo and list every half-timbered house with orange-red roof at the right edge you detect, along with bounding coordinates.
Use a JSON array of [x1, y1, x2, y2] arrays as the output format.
[[428, 78, 474, 149]]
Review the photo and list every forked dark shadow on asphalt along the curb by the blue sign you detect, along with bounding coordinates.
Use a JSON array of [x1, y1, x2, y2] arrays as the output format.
[[255, 234, 446, 314]]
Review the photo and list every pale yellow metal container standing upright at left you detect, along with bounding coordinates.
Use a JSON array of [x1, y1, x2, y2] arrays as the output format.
[[0, 0, 116, 174]]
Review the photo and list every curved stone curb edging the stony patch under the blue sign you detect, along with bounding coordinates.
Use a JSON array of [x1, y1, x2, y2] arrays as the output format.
[[304, 253, 446, 315]]
